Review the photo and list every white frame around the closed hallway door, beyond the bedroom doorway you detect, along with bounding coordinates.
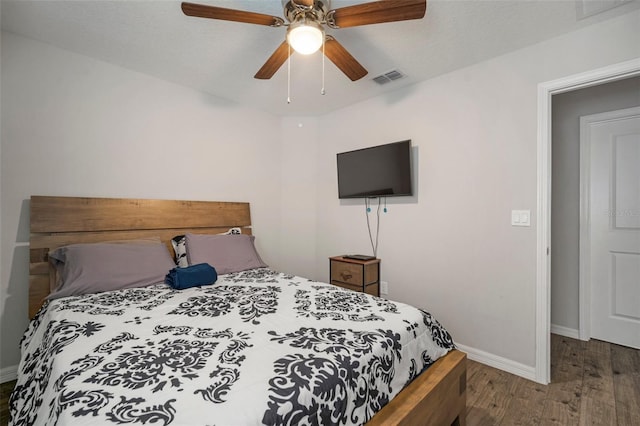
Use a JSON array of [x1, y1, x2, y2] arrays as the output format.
[[579, 107, 640, 340]]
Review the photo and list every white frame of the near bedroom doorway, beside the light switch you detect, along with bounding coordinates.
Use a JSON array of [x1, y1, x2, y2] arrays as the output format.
[[535, 58, 640, 384]]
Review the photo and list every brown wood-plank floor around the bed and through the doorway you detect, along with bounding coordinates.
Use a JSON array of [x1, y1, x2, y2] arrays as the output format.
[[0, 335, 640, 426]]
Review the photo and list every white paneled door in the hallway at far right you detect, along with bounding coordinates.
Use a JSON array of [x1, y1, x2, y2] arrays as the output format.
[[580, 108, 640, 348]]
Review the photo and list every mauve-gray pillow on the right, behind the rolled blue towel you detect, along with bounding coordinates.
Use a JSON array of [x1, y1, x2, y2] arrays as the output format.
[[186, 234, 267, 274]]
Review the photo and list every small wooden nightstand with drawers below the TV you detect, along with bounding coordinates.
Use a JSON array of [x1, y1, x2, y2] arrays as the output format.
[[329, 256, 380, 296]]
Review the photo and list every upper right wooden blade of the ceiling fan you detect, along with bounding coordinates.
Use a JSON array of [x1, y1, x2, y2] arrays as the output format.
[[329, 0, 427, 28]]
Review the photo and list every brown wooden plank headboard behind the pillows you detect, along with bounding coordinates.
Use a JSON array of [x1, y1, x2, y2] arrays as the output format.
[[29, 196, 251, 318]]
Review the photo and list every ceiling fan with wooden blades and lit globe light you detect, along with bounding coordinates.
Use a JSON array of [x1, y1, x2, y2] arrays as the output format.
[[182, 0, 427, 81]]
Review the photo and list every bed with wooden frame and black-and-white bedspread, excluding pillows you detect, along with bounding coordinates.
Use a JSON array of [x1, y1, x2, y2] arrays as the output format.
[[10, 196, 466, 425]]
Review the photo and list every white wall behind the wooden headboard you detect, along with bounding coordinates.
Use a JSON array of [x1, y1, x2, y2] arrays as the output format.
[[0, 33, 282, 372]]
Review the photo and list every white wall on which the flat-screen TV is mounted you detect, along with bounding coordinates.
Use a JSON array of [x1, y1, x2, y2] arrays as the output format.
[[304, 8, 640, 377]]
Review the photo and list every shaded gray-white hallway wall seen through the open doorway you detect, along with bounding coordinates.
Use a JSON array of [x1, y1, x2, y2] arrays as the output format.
[[551, 77, 640, 336]]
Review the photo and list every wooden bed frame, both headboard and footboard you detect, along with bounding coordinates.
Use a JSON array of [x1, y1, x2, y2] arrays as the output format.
[[29, 196, 467, 426]]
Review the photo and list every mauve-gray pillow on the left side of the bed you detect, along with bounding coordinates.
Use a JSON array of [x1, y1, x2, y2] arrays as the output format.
[[48, 241, 175, 299]]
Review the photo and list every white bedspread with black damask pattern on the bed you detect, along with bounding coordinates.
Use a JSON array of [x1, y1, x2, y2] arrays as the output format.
[[10, 269, 453, 426]]
